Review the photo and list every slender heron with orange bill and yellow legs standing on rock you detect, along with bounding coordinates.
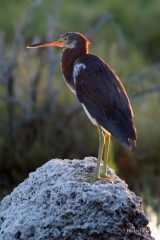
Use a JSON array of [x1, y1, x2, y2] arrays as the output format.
[[28, 32, 136, 182]]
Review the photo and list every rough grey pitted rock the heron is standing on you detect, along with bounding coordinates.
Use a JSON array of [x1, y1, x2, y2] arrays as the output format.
[[0, 157, 153, 240]]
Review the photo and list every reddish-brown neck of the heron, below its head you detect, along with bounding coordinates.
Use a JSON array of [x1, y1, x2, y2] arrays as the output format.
[[61, 46, 88, 92]]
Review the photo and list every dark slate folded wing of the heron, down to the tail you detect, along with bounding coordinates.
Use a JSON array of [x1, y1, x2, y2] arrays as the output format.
[[75, 54, 136, 147]]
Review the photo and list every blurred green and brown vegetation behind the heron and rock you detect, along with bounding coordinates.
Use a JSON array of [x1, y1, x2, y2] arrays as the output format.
[[0, 0, 160, 227]]
